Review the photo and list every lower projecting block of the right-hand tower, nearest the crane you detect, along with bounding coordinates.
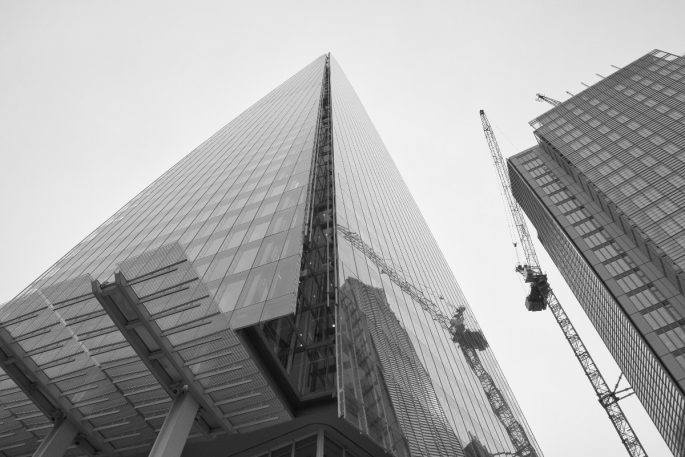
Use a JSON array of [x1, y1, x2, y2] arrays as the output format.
[[509, 148, 685, 455]]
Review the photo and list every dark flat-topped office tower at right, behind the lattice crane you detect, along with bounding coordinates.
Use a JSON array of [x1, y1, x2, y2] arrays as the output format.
[[508, 51, 685, 456]]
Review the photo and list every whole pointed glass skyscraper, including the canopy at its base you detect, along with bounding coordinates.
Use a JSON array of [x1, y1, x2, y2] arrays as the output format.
[[0, 56, 542, 457]]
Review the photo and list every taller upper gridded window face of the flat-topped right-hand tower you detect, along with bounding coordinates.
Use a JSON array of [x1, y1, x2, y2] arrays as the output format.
[[533, 51, 685, 271]]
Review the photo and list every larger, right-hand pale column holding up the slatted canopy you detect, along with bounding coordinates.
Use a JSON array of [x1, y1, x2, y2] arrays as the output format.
[[149, 393, 198, 457]]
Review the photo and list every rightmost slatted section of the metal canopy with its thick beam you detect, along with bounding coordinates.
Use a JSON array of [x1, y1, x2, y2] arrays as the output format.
[[107, 243, 292, 434]]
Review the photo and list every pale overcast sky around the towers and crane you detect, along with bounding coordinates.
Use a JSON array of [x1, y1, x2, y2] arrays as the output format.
[[0, 0, 685, 457]]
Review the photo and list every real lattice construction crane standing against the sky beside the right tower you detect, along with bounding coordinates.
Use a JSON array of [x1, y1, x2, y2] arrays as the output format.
[[480, 110, 647, 457]]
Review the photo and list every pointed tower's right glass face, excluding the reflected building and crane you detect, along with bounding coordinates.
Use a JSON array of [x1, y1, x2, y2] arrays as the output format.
[[331, 59, 541, 455]]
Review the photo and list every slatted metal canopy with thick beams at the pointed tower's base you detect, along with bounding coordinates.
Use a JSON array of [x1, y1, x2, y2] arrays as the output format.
[[0, 240, 293, 457]]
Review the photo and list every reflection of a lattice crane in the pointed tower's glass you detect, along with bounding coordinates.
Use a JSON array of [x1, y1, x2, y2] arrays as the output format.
[[338, 225, 537, 457]]
